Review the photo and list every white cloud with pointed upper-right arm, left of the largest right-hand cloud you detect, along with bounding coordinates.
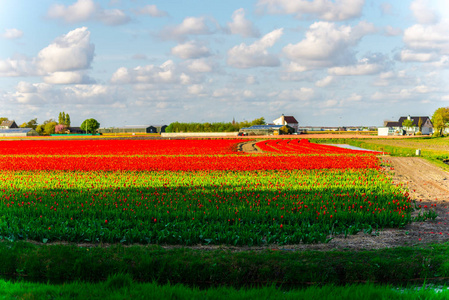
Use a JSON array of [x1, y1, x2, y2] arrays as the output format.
[[227, 28, 283, 69]]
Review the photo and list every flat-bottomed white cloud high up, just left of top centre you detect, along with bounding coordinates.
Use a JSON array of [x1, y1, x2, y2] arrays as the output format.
[[159, 17, 213, 40]]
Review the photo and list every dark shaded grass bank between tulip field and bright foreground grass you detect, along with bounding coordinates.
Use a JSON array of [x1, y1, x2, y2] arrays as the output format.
[[0, 242, 449, 288]]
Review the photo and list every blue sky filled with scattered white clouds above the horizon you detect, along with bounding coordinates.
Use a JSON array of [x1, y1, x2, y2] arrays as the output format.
[[0, 0, 449, 127]]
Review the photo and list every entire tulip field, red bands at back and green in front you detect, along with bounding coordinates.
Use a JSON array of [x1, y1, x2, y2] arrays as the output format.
[[0, 139, 415, 246]]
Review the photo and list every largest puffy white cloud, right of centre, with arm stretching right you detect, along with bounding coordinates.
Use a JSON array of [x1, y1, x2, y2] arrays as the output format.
[[283, 21, 376, 70]]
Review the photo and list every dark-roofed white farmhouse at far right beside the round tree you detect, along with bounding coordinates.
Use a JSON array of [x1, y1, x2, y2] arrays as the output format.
[[377, 116, 433, 136]]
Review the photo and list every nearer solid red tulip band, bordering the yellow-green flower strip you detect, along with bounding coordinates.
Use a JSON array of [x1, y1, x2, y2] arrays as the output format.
[[0, 154, 379, 171]]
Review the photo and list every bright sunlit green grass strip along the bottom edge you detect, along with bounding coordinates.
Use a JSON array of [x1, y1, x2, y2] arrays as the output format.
[[0, 275, 449, 300]]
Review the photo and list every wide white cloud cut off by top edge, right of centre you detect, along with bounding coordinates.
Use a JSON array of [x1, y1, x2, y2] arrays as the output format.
[[257, 0, 365, 21]]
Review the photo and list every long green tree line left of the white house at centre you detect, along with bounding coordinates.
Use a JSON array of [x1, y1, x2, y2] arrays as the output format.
[[165, 117, 265, 132]]
